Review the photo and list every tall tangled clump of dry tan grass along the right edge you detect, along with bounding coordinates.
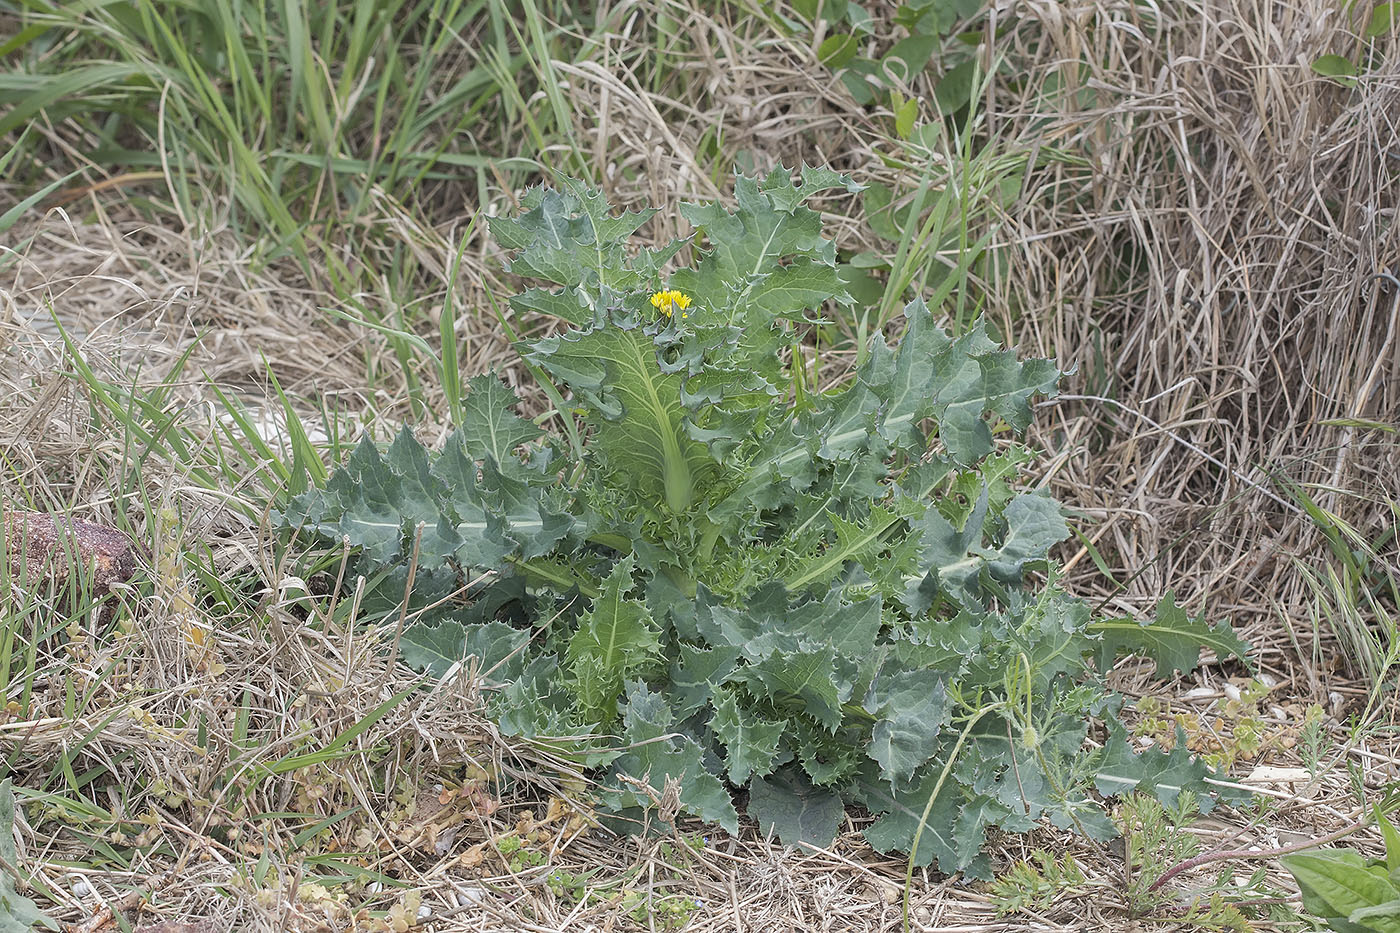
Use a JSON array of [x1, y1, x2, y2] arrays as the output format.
[[990, 0, 1400, 683]]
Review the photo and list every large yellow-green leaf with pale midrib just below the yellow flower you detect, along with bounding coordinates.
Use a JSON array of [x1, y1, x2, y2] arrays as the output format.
[[529, 319, 715, 514]]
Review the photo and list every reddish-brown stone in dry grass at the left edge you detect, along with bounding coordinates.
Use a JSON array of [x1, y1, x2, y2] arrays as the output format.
[[0, 511, 136, 597]]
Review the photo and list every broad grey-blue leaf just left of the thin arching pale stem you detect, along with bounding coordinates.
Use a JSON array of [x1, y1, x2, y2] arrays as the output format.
[[865, 668, 949, 782]]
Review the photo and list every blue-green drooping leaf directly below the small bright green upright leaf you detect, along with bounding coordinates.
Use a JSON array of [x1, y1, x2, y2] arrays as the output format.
[[613, 681, 739, 832]]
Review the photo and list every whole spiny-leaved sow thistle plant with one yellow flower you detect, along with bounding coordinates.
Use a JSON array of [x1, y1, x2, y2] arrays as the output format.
[[283, 168, 1245, 876]]
